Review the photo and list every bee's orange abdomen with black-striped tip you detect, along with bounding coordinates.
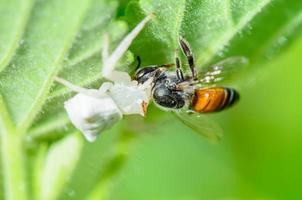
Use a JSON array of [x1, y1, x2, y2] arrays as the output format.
[[192, 87, 239, 113]]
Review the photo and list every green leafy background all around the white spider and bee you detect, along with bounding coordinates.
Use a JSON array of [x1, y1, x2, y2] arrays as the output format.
[[0, 0, 302, 200]]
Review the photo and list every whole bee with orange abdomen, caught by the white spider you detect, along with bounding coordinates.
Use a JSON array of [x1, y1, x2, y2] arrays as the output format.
[[134, 37, 248, 140]]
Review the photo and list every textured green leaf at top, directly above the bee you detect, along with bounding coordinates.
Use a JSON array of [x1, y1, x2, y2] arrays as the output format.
[[126, 0, 302, 66]]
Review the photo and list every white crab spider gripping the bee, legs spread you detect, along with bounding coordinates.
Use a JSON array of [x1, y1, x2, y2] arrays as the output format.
[[55, 14, 153, 142]]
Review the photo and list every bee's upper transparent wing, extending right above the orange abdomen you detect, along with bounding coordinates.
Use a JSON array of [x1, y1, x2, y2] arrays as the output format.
[[198, 56, 249, 84]]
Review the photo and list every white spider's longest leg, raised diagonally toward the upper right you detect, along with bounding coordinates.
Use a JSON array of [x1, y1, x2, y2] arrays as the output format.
[[102, 14, 154, 81]]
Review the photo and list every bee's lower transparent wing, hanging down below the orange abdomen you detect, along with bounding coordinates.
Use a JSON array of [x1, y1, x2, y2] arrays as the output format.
[[173, 109, 222, 143]]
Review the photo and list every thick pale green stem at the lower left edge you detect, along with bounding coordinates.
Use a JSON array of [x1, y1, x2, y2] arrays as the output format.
[[0, 95, 28, 200]]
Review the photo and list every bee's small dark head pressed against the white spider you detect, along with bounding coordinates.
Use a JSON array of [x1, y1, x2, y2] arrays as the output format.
[[134, 66, 162, 84]]
